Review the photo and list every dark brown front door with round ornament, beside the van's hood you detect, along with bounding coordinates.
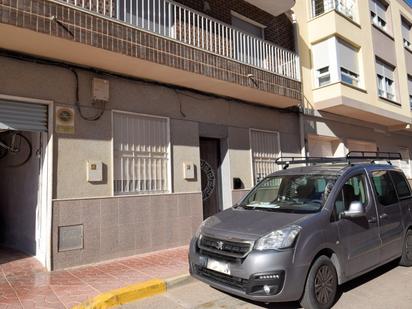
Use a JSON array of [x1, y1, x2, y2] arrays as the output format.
[[200, 138, 220, 219]]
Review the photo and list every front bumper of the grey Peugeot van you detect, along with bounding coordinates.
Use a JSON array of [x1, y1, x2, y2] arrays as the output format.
[[189, 239, 309, 302]]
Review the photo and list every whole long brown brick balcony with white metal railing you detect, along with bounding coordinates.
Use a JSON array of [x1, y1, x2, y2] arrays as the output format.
[[0, 0, 301, 107]]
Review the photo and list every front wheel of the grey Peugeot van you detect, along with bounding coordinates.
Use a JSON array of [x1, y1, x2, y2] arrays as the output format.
[[300, 255, 338, 309]]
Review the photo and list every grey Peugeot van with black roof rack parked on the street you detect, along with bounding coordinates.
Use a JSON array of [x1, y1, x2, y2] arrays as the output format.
[[189, 153, 412, 308]]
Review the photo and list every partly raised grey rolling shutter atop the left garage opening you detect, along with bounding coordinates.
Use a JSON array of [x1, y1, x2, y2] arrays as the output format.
[[0, 100, 48, 132]]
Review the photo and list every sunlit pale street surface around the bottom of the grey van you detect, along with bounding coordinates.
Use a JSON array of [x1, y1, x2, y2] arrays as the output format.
[[121, 262, 412, 309]]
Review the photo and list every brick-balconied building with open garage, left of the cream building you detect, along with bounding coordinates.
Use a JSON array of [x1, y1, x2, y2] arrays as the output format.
[[0, 0, 302, 269]]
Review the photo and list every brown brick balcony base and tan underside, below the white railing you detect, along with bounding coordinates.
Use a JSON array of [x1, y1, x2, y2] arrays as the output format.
[[0, 0, 301, 108]]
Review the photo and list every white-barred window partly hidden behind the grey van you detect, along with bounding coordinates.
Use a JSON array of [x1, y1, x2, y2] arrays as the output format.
[[250, 130, 280, 184]]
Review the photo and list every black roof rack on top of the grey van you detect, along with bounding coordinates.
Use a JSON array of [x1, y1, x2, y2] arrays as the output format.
[[276, 151, 402, 169]]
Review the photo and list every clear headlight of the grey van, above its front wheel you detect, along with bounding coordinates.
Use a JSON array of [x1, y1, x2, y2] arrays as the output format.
[[255, 225, 302, 251]]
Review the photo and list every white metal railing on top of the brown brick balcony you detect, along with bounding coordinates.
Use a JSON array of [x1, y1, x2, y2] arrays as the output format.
[[57, 0, 300, 81]]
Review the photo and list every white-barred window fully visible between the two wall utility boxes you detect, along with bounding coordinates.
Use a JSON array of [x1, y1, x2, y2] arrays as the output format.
[[113, 112, 170, 195]]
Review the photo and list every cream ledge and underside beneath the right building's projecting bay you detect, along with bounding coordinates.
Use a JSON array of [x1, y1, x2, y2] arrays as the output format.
[[314, 96, 410, 127]]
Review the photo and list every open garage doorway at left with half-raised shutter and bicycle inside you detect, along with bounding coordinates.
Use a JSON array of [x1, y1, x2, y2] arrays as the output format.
[[0, 95, 52, 268]]
